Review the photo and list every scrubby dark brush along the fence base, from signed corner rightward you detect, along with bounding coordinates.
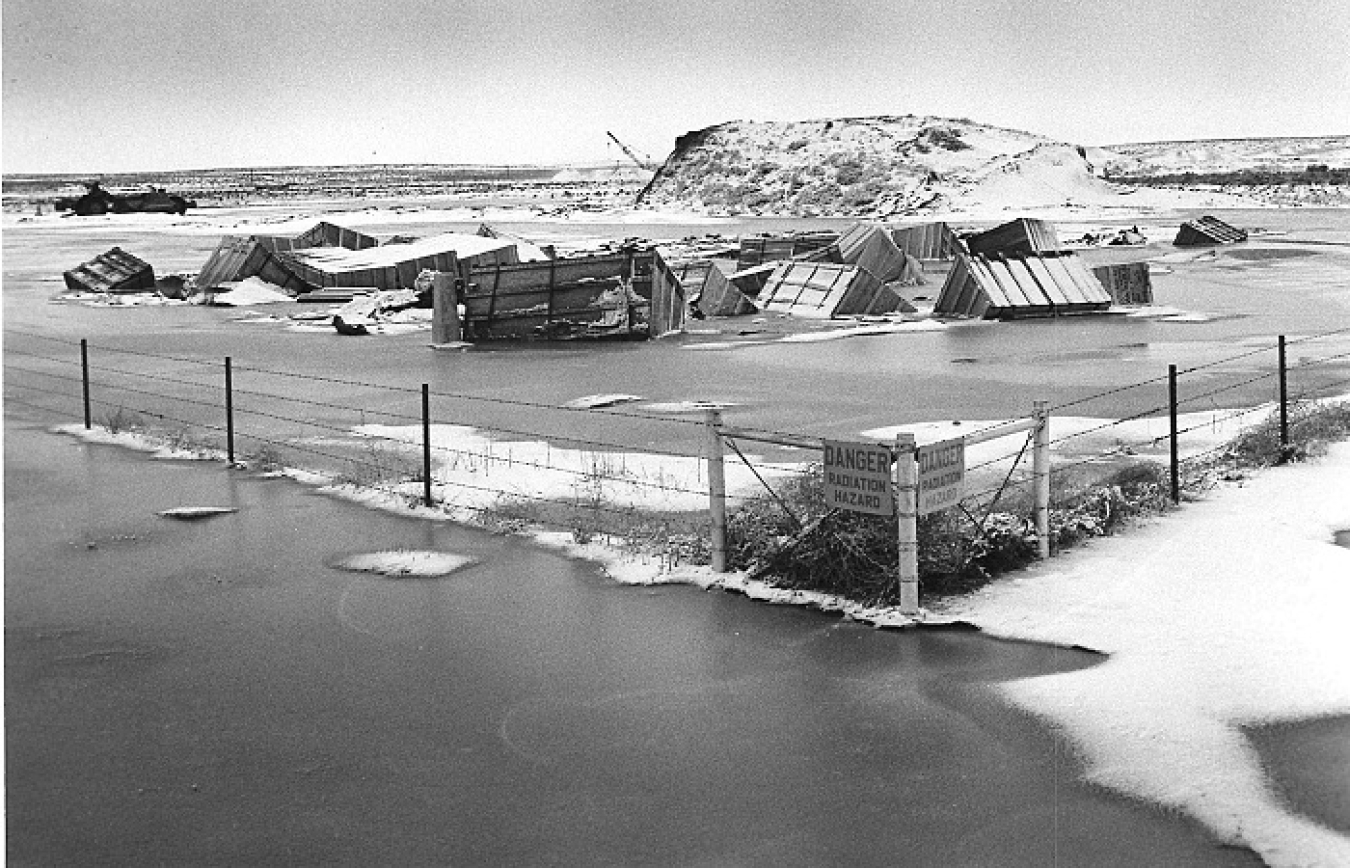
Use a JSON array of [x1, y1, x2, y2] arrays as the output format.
[[728, 404, 1350, 605]]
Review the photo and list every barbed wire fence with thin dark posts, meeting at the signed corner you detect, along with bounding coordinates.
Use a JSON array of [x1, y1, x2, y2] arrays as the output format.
[[4, 329, 1350, 601]]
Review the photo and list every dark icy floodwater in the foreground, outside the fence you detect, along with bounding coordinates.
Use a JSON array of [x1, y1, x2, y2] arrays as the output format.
[[5, 418, 1258, 868]]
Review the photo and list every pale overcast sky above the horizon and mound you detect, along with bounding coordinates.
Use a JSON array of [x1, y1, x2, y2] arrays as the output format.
[[3, 0, 1350, 173]]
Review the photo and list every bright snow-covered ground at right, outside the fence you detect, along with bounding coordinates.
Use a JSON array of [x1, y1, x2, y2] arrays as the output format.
[[942, 443, 1350, 867]]
